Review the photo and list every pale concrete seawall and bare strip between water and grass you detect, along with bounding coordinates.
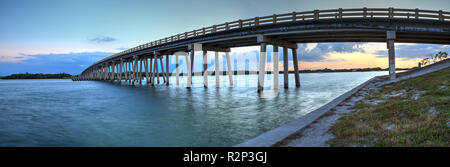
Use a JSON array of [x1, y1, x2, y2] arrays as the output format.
[[234, 60, 450, 147]]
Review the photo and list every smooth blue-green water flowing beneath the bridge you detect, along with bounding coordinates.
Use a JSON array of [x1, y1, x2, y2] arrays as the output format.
[[0, 72, 387, 146]]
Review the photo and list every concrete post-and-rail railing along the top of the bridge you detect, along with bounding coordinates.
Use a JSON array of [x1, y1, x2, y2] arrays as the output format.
[[88, 8, 450, 68]]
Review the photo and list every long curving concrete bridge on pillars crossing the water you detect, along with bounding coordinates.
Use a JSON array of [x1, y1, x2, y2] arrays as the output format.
[[73, 8, 450, 91]]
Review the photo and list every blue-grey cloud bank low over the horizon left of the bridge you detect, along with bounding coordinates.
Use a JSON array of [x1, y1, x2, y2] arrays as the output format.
[[0, 52, 114, 76]]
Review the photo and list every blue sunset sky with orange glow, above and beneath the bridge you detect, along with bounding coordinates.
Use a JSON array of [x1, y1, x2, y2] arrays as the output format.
[[0, 0, 450, 76]]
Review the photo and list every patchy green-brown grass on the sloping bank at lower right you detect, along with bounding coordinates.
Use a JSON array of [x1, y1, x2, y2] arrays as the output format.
[[328, 68, 450, 147]]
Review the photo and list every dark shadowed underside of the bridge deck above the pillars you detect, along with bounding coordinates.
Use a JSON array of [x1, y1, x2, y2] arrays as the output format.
[[159, 19, 450, 52]]
